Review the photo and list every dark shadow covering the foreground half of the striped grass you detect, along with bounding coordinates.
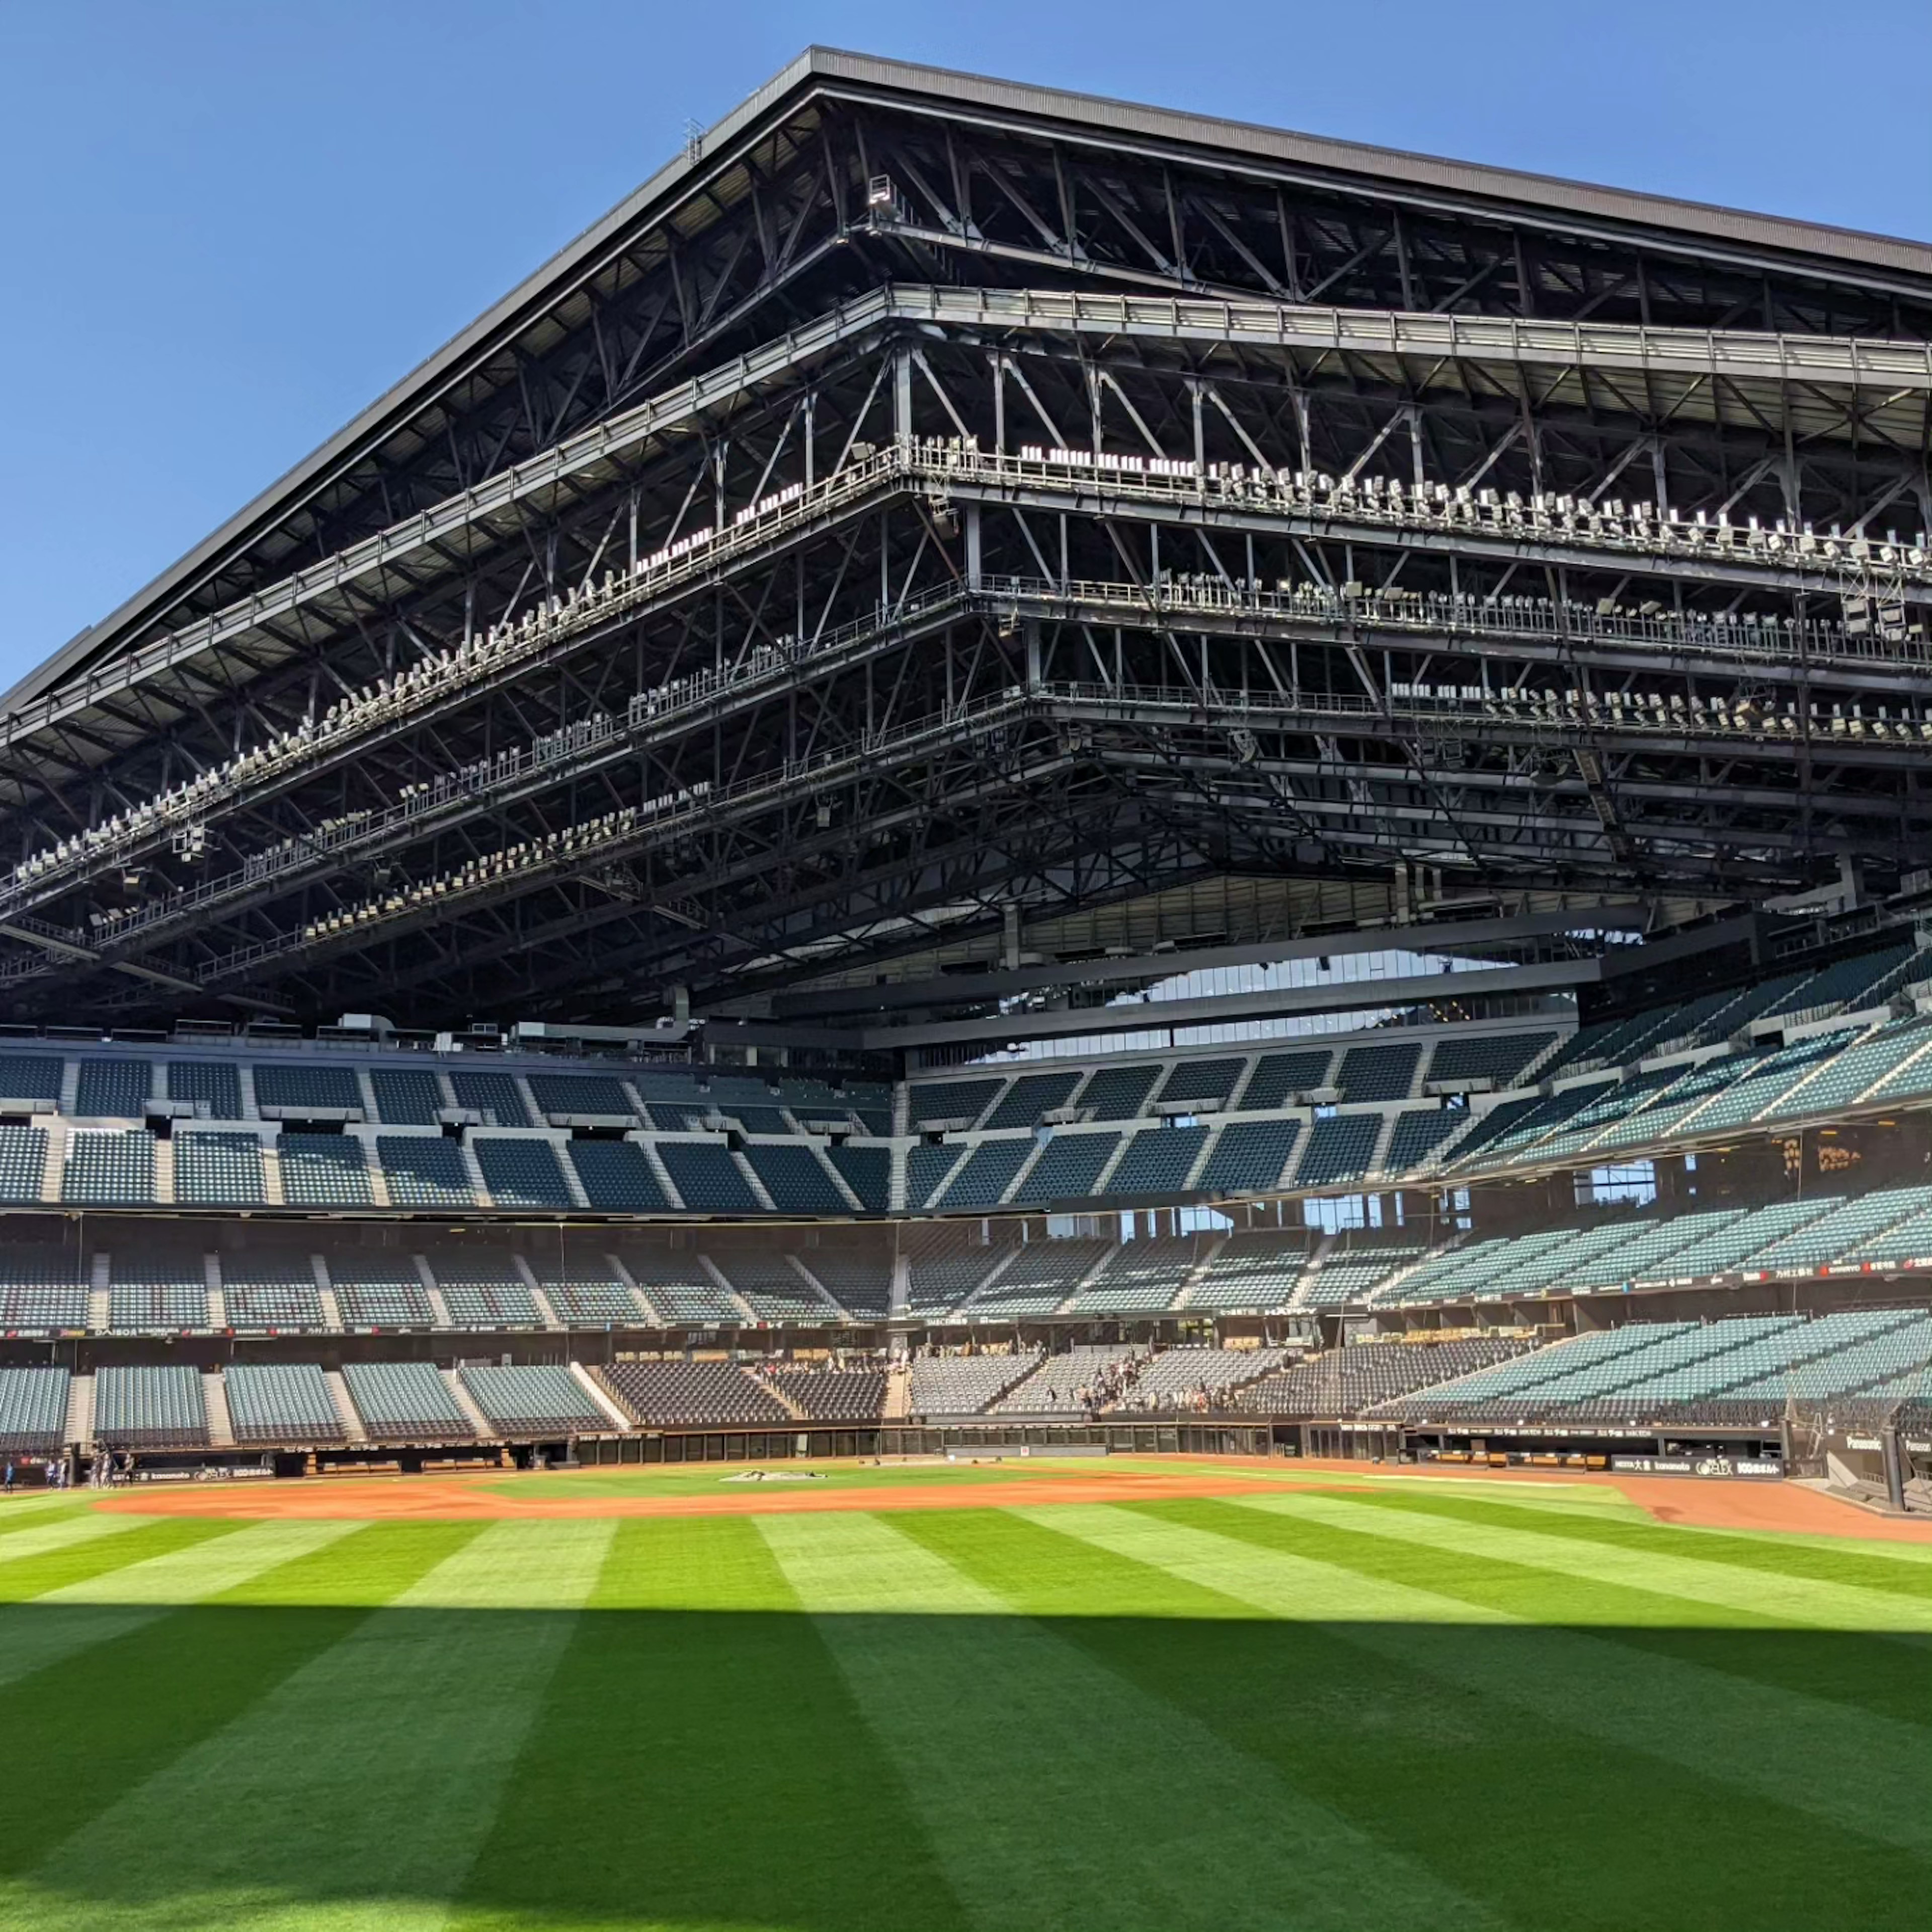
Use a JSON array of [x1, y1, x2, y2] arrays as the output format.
[[0, 1605, 1932, 1932]]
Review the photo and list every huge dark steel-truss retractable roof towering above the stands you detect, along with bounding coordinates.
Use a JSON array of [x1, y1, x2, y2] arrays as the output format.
[[0, 50, 1932, 1043]]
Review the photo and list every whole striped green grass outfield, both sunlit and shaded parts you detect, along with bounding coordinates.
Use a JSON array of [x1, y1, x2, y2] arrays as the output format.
[[0, 1467, 1932, 1932]]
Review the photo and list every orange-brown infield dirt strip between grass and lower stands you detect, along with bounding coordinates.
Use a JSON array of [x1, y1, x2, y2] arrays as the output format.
[[99, 1457, 1932, 1546]]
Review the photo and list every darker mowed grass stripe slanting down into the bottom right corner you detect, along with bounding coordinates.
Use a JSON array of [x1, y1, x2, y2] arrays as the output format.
[[927, 1509, 1918, 1932]]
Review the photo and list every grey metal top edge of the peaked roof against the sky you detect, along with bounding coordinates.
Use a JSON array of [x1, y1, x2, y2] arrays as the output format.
[[0, 46, 1932, 713]]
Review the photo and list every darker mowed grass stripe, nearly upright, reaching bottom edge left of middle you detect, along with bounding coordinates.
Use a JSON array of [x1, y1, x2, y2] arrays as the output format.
[[454, 1516, 970, 1932]]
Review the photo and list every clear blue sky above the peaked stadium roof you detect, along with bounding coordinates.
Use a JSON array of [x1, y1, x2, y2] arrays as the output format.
[[0, 0, 1932, 688]]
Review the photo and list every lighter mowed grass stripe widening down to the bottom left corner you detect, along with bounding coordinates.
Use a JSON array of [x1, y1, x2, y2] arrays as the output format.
[[15, 1522, 612, 1932]]
